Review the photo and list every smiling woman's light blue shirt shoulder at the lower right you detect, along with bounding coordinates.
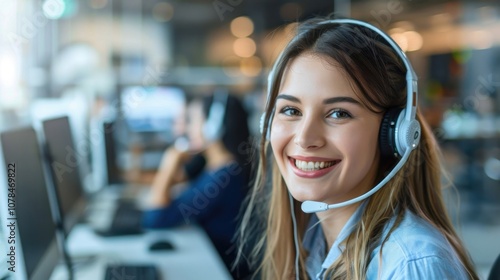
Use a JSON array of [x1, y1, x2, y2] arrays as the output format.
[[369, 211, 466, 279]]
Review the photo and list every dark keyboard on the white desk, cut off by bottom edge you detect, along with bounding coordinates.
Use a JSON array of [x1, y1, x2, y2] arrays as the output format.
[[104, 264, 160, 280]]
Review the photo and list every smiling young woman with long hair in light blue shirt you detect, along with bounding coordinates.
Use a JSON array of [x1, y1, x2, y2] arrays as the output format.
[[236, 19, 478, 279]]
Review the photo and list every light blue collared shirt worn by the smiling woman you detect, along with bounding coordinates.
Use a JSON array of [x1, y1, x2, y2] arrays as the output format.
[[303, 203, 468, 280]]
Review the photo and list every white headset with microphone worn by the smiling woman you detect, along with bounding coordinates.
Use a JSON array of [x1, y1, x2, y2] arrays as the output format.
[[260, 19, 421, 213]]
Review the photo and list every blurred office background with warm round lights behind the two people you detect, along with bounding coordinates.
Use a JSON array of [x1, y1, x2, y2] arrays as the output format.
[[0, 0, 500, 277]]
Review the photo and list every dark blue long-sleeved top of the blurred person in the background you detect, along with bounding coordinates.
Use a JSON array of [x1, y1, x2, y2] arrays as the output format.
[[143, 162, 247, 258]]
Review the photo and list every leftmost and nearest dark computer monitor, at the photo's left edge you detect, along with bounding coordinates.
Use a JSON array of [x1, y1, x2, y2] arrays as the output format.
[[0, 127, 61, 280]]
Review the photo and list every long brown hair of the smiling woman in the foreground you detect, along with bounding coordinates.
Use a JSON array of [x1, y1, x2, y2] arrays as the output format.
[[239, 19, 478, 279]]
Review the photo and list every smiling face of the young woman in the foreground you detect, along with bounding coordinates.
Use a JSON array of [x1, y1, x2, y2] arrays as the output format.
[[270, 53, 382, 203]]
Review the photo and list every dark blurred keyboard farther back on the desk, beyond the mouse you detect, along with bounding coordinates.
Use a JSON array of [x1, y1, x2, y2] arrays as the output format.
[[98, 201, 143, 236]]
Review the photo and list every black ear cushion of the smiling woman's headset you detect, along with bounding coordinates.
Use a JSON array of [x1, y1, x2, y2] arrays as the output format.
[[379, 108, 403, 158]]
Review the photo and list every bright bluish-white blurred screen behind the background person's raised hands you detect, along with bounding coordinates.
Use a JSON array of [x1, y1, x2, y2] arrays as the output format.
[[120, 86, 185, 132]]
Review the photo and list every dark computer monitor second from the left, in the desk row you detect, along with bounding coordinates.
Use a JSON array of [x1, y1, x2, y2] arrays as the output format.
[[42, 116, 86, 234]]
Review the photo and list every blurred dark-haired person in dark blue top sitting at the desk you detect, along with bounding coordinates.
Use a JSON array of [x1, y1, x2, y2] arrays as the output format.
[[143, 91, 254, 279]]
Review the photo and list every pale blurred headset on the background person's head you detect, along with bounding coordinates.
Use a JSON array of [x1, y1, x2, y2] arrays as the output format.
[[202, 89, 229, 143]]
